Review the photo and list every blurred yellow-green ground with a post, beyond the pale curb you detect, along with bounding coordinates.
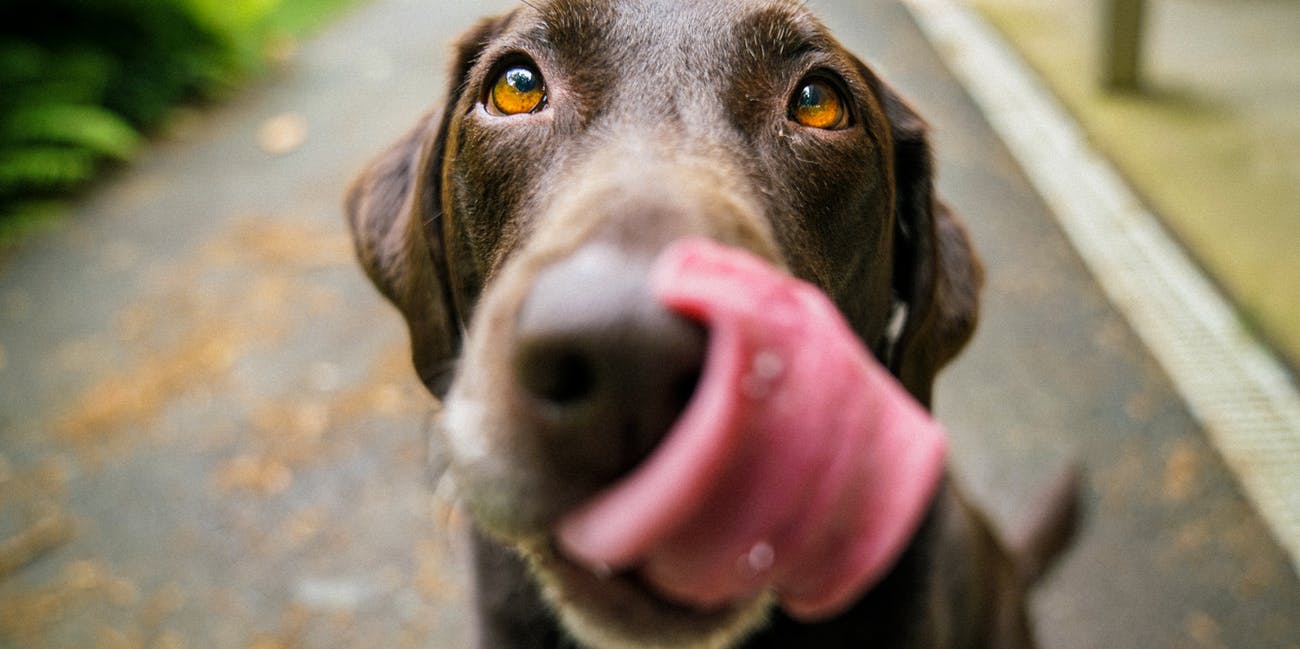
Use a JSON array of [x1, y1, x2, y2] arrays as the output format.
[[969, 0, 1300, 379]]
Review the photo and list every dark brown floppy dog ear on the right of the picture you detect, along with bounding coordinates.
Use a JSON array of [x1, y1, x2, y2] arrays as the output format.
[[881, 86, 984, 407]]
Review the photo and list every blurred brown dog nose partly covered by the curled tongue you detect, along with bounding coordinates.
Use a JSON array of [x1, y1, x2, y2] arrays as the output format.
[[514, 246, 707, 488]]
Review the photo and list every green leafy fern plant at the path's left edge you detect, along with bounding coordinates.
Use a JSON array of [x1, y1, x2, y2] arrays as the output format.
[[0, 0, 278, 236]]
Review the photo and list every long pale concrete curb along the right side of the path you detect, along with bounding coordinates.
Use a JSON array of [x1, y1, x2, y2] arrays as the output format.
[[902, 0, 1300, 575]]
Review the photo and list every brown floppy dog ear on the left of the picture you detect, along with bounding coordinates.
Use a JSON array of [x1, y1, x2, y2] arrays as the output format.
[[345, 16, 508, 397]]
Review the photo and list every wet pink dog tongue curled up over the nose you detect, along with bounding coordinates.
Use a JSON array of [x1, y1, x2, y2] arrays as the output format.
[[558, 239, 946, 619]]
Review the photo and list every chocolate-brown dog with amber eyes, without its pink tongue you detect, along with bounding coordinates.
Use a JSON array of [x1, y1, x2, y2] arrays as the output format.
[[347, 0, 1075, 649]]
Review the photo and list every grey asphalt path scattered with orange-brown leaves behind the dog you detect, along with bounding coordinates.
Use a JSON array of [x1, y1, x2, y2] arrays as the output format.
[[0, 0, 1300, 649]]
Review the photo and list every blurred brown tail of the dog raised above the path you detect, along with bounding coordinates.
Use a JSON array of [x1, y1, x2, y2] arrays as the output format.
[[1008, 466, 1083, 585]]
